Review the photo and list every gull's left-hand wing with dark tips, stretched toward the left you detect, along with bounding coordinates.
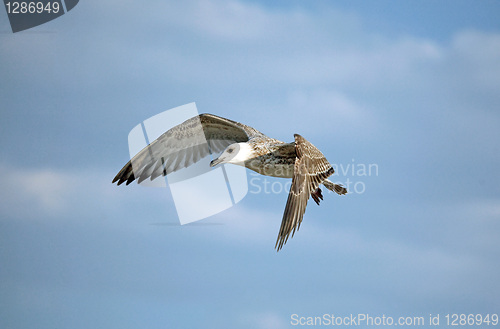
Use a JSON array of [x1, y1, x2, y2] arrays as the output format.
[[113, 114, 263, 185]]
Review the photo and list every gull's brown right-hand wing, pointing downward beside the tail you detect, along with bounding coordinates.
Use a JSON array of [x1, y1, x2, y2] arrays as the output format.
[[275, 134, 334, 251]]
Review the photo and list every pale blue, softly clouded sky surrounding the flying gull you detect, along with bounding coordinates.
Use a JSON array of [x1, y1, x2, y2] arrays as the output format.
[[0, 0, 500, 328]]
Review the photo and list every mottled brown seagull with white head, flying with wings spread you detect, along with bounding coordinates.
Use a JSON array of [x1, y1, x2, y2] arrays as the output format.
[[113, 114, 347, 251]]
